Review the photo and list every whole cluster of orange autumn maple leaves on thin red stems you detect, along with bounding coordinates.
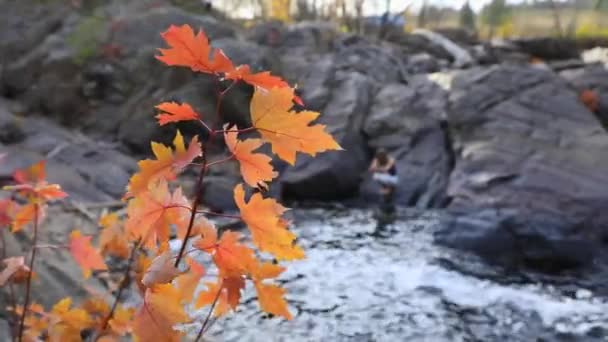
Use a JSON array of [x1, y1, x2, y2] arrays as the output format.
[[0, 25, 340, 342]]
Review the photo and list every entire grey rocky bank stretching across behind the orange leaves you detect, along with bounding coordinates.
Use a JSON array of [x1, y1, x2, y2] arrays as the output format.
[[0, 1, 608, 294]]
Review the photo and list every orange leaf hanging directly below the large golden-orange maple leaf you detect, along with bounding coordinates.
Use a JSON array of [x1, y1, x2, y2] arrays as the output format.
[[224, 126, 279, 188]]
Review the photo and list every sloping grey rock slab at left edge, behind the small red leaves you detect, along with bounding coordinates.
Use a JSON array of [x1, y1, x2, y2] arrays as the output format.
[[0, 102, 136, 202]]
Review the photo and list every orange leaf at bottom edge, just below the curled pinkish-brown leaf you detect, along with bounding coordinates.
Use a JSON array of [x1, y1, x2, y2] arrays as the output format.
[[133, 284, 188, 342]]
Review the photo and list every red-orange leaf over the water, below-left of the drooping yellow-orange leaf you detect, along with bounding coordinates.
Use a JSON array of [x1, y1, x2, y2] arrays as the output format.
[[194, 227, 257, 278]]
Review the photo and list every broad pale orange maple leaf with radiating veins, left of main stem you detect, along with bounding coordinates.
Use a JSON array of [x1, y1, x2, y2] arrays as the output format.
[[125, 181, 190, 248]]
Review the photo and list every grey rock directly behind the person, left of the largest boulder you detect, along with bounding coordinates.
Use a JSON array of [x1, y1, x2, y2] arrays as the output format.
[[362, 76, 451, 207]]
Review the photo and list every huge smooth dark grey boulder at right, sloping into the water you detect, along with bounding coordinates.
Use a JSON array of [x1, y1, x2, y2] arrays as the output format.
[[438, 66, 608, 271]]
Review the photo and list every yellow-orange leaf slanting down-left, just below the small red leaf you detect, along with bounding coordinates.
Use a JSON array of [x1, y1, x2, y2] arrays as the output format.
[[125, 131, 202, 198]]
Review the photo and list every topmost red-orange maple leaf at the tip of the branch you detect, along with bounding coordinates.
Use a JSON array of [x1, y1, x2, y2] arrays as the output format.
[[156, 25, 234, 74]]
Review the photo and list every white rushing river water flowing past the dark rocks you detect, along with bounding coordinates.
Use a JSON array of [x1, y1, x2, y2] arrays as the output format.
[[185, 209, 608, 341]]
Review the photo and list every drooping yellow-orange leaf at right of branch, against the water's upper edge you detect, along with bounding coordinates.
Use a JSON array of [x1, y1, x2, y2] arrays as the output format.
[[234, 184, 304, 260]]
